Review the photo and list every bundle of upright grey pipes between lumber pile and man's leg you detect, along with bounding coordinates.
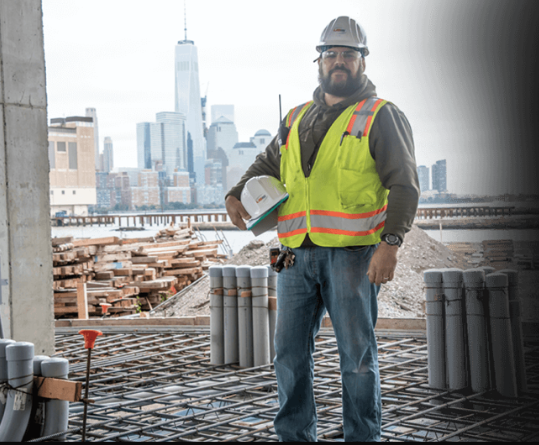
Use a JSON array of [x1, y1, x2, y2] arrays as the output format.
[[209, 266, 277, 368]]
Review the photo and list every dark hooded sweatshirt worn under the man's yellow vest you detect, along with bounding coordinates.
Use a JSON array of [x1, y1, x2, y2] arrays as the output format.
[[227, 75, 420, 245]]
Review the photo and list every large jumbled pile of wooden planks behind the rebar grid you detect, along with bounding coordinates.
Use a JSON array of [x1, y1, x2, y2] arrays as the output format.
[[52, 227, 224, 318]]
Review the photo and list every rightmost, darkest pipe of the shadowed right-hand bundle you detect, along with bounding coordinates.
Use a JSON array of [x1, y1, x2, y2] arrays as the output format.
[[500, 269, 528, 392]]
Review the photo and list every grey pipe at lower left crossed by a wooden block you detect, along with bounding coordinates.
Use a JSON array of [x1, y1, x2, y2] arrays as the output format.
[[41, 358, 69, 441]]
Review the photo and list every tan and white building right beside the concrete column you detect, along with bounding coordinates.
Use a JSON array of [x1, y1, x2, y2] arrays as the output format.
[[48, 116, 97, 216]]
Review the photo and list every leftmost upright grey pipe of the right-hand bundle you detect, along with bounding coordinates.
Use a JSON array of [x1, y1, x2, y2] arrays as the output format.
[[423, 269, 447, 389]]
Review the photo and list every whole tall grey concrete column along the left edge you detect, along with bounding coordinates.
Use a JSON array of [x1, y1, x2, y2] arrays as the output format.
[[0, 0, 54, 354]]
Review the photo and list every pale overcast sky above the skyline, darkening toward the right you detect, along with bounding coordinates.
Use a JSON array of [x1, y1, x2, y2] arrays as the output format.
[[43, 0, 536, 194]]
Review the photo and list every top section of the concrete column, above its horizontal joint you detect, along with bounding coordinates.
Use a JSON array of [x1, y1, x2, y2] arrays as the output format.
[[0, 0, 47, 107]]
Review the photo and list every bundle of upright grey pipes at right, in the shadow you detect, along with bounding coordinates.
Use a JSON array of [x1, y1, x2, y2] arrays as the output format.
[[423, 268, 526, 397]]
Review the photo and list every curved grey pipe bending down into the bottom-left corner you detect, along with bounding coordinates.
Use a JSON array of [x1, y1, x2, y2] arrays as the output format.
[[0, 342, 34, 442]]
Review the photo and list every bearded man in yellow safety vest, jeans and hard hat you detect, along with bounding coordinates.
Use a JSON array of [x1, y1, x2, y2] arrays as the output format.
[[226, 17, 419, 442]]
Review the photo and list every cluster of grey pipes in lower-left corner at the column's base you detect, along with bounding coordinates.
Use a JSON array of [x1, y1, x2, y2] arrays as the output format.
[[0, 339, 69, 442]]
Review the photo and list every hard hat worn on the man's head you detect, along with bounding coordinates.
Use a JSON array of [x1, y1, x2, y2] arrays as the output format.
[[316, 16, 369, 56]]
